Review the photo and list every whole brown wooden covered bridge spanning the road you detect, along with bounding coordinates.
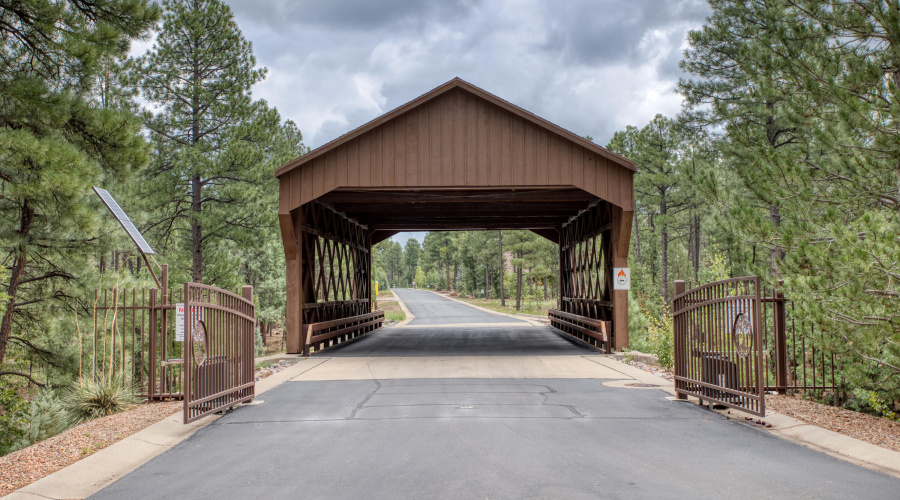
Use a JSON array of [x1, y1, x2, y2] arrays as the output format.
[[275, 78, 635, 353]]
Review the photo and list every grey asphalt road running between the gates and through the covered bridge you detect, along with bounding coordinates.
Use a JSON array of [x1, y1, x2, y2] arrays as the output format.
[[91, 292, 900, 499]]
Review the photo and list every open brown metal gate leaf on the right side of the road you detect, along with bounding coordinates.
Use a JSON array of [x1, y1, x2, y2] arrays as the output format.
[[673, 276, 766, 416]]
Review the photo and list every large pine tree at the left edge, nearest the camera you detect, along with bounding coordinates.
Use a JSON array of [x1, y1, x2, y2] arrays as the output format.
[[0, 0, 159, 378]]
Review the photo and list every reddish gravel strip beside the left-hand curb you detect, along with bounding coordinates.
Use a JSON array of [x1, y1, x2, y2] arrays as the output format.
[[0, 401, 182, 497]]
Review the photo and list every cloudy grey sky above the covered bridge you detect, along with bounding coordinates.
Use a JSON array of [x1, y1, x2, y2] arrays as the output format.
[[178, 0, 709, 245]]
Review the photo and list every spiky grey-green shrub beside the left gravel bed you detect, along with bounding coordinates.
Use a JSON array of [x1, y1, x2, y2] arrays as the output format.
[[62, 377, 138, 425]]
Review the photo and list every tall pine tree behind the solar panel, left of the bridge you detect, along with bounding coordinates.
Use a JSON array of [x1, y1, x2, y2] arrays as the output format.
[[129, 0, 286, 283]]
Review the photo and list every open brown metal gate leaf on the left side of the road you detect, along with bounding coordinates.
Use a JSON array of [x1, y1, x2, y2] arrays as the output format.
[[184, 283, 256, 424]]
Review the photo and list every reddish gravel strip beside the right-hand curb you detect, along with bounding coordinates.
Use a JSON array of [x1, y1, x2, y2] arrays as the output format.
[[766, 395, 900, 452]]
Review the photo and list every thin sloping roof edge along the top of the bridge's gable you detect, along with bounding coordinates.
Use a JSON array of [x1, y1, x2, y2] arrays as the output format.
[[275, 77, 637, 177]]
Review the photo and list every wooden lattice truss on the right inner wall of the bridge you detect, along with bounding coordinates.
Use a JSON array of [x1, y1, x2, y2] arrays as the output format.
[[559, 202, 612, 320]]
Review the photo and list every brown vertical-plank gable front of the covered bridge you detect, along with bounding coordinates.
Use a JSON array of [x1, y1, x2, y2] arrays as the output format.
[[276, 78, 634, 214]]
